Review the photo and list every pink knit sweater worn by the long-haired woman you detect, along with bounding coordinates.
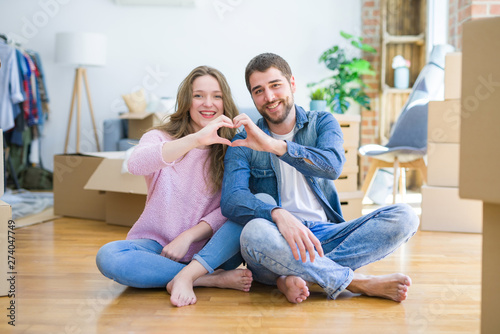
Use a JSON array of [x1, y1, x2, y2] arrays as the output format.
[[127, 130, 226, 262]]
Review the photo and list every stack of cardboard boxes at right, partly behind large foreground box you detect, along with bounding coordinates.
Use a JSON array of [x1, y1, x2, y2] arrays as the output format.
[[421, 52, 482, 233]]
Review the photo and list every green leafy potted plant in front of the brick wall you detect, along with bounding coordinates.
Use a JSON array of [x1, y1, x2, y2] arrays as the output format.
[[308, 31, 376, 114]]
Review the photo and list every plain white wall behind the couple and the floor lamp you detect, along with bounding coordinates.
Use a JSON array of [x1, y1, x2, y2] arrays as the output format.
[[0, 0, 361, 169]]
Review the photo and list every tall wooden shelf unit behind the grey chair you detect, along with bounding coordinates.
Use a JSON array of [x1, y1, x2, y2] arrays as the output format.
[[380, 0, 427, 144]]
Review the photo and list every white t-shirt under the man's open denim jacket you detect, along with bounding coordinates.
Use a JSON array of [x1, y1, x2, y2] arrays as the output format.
[[272, 127, 327, 222]]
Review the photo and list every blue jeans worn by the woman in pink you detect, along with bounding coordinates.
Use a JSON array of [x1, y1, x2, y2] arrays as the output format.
[[96, 221, 243, 288]]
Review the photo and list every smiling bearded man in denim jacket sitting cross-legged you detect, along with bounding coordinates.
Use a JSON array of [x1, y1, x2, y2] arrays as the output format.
[[221, 53, 419, 303]]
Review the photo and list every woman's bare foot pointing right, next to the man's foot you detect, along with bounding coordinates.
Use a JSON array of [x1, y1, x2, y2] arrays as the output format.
[[194, 269, 253, 292]]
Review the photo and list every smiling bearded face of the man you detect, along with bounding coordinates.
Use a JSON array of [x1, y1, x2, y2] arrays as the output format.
[[249, 67, 296, 124]]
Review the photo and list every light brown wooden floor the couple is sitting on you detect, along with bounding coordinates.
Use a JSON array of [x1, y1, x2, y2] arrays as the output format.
[[0, 218, 482, 334]]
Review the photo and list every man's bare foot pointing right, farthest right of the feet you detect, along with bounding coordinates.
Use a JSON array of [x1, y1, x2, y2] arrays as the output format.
[[347, 273, 411, 302]]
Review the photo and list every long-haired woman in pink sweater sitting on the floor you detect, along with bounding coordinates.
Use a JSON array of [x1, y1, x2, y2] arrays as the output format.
[[96, 66, 252, 306]]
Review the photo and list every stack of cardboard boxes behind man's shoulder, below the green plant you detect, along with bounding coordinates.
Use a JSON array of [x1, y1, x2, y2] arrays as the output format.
[[334, 114, 363, 221]]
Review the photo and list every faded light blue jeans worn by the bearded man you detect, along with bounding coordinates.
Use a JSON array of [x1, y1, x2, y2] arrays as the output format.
[[240, 194, 419, 299]]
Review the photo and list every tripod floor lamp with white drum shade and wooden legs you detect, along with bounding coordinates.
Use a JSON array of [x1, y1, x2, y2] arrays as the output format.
[[56, 32, 106, 153]]
